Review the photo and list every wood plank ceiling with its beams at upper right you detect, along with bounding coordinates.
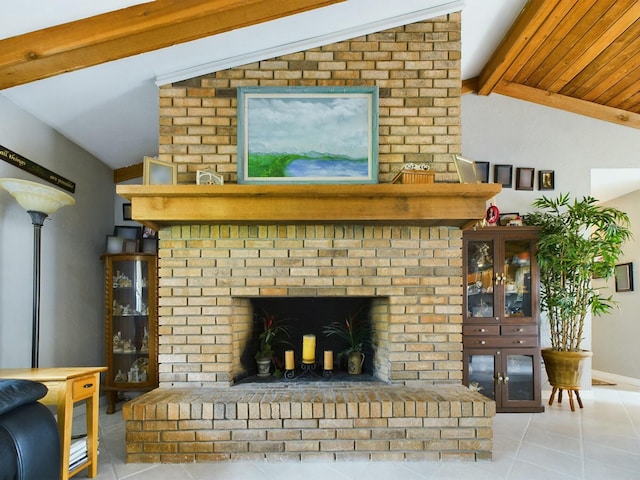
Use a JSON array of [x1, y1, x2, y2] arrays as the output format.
[[463, 0, 640, 128]]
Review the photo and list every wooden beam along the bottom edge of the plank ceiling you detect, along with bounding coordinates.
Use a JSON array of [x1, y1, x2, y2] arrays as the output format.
[[494, 81, 640, 129]]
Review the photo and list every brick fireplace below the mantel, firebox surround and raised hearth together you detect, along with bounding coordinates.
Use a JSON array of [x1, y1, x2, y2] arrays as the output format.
[[124, 225, 495, 462]]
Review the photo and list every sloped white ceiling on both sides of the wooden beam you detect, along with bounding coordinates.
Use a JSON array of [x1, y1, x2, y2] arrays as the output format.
[[0, 0, 637, 201]]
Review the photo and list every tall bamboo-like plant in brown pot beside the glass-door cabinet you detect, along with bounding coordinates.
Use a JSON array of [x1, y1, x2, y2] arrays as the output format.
[[525, 194, 631, 400]]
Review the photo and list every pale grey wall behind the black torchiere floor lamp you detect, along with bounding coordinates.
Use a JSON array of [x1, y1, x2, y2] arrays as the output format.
[[0, 95, 115, 368]]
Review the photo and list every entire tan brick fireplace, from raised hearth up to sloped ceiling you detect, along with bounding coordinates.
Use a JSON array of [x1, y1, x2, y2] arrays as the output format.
[[119, 14, 495, 462]]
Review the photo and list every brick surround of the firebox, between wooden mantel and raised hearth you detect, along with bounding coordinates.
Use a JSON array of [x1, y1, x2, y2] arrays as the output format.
[[159, 225, 462, 387]]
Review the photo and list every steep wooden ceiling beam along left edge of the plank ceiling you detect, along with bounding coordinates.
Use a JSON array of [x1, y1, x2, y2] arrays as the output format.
[[478, 0, 559, 95]]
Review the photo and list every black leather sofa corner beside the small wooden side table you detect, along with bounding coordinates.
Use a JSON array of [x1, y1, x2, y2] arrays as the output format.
[[0, 380, 60, 480]]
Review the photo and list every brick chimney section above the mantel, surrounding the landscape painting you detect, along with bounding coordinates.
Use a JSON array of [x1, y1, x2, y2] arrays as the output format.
[[159, 13, 462, 183]]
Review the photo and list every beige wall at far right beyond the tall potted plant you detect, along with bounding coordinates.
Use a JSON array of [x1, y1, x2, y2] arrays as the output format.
[[593, 191, 640, 379]]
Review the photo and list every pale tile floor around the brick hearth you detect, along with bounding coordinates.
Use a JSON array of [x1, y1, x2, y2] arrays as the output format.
[[74, 384, 640, 480]]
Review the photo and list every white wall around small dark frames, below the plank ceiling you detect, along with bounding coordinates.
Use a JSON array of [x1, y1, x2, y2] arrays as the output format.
[[462, 95, 640, 378]]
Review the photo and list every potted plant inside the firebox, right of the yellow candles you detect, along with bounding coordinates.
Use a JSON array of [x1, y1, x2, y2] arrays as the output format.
[[323, 313, 373, 375]]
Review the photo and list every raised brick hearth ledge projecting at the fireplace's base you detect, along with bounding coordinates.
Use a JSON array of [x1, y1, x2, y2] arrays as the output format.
[[123, 384, 495, 463]]
